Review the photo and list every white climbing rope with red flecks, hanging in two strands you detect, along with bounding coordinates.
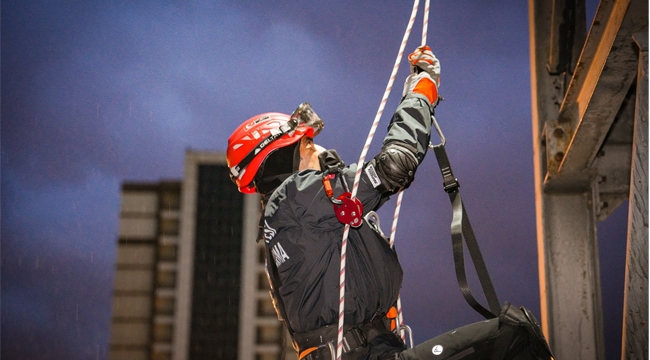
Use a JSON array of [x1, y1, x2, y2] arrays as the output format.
[[336, 0, 429, 360]]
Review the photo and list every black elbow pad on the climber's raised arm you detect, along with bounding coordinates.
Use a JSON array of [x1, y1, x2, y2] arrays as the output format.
[[364, 143, 418, 194]]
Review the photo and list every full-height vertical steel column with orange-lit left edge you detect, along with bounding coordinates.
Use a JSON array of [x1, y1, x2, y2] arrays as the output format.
[[529, 0, 604, 360]]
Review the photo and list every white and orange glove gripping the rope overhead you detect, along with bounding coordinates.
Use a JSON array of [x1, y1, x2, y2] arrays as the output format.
[[402, 45, 440, 106]]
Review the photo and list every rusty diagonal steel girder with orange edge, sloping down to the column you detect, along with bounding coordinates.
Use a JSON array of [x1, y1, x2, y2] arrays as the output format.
[[544, 0, 648, 191]]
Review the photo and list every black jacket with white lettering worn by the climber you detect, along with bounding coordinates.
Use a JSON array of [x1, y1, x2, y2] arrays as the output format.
[[261, 94, 432, 332]]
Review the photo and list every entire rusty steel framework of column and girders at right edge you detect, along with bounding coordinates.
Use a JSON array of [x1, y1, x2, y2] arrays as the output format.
[[529, 0, 648, 359]]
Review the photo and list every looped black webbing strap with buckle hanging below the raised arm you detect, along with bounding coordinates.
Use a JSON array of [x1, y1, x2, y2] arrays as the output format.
[[433, 144, 501, 319]]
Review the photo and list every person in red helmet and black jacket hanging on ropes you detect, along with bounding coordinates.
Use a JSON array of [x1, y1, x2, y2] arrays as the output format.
[[227, 46, 548, 360]]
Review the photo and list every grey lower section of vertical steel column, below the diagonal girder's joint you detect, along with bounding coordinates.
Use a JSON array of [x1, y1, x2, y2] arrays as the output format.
[[538, 190, 605, 360]]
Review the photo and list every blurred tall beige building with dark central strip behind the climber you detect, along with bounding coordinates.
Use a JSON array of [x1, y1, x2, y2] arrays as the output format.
[[109, 151, 295, 360]]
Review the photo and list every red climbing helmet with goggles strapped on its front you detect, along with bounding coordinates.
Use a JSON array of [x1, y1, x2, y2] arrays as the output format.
[[226, 103, 323, 194]]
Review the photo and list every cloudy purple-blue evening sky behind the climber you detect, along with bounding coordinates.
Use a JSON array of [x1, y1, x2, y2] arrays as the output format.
[[1, 0, 627, 360]]
